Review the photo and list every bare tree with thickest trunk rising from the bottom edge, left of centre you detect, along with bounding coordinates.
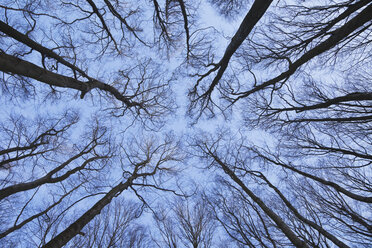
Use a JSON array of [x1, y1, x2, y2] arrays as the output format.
[[43, 134, 181, 247]]
